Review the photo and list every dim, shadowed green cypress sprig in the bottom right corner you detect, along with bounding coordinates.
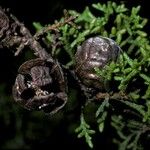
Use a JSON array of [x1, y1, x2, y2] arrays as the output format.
[[111, 115, 147, 150]]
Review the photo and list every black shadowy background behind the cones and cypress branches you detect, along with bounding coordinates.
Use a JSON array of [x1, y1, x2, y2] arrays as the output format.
[[0, 0, 150, 150]]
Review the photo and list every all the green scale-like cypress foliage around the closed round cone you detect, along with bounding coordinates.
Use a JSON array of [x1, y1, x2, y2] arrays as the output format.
[[31, 1, 150, 150]]
